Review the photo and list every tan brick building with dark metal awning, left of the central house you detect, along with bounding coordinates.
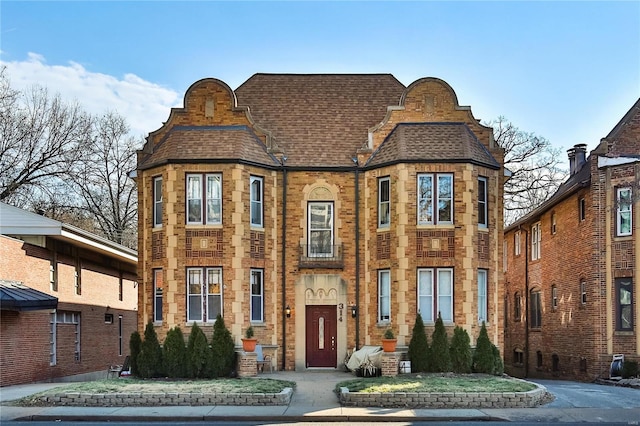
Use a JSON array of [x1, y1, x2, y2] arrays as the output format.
[[0, 203, 138, 386]]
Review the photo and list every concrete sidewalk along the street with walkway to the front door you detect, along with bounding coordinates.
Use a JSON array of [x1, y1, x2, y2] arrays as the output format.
[[0, 370, 640, 424]]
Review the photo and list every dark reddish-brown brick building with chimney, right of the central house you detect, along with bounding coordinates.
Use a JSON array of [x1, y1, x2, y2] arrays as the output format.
[[504, 100, 640, 380]]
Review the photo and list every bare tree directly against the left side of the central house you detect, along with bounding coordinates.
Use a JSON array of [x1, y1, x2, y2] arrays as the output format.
[[70, 112, 138, 248]]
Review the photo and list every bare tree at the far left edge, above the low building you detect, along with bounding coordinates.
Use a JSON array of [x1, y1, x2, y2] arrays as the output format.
[[0, 68, 90, 206]]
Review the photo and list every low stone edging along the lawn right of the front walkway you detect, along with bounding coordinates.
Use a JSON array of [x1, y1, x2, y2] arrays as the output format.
[[339, 383, 547, 408]]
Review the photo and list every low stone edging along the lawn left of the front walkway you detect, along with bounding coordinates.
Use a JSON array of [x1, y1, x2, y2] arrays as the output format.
[[28, 388, 293, 407]]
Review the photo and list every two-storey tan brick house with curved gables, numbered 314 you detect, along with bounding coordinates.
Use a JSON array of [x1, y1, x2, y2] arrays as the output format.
[[136, 74, 505, 371]]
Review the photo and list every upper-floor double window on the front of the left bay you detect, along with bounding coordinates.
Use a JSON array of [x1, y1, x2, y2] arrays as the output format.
[[187, 174, 222, 225]]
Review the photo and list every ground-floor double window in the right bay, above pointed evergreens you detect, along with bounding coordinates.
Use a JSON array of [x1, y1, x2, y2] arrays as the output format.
[[418, 268, 453, 323]]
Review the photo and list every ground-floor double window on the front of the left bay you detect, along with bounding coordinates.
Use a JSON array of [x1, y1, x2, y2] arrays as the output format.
[[187, 268, 222, 322]]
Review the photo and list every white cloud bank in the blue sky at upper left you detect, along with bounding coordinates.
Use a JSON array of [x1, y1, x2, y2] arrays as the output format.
[[0, 53, 183, 136]]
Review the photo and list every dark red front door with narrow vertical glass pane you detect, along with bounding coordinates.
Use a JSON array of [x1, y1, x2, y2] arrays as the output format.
[[306, 305, 338, 368]]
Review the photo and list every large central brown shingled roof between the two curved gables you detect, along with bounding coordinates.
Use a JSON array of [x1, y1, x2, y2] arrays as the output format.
[[235, 74, 405, 167]]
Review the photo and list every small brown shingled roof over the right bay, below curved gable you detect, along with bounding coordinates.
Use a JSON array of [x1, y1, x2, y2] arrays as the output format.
[[366, 123, 500, 169]]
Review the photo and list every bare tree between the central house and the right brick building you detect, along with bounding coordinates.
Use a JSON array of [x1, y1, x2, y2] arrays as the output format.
[[485, 116, 567, 225]]
